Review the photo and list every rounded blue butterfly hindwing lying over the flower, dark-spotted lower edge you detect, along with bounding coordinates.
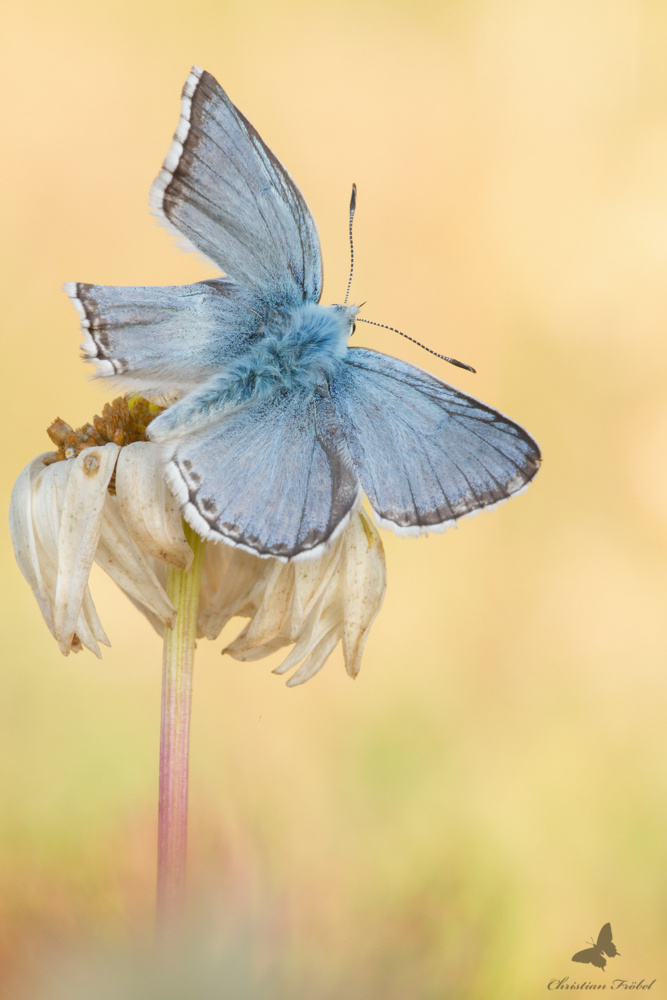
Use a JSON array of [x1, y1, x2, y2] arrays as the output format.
[[164, 386, 361, 561]]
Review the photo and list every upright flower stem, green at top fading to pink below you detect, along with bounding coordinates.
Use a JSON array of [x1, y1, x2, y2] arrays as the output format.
[[157, 522, 206, 938]]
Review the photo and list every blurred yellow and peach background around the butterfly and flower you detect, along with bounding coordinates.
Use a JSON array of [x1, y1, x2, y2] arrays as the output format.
[[0, 0, 667, 1000]]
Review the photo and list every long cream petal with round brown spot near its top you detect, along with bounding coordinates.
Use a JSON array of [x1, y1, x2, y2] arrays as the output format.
[[54, 444, 120, 652]]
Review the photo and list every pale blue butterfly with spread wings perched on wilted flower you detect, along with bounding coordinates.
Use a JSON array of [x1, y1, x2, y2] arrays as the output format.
[[65, 67, 540, 560]]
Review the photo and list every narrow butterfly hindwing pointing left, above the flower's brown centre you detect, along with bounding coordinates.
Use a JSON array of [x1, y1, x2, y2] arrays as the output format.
[[65, 278, 264, 392]]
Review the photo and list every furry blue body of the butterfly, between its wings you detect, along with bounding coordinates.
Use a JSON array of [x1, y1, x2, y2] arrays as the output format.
[[149, 302, 358, 442]]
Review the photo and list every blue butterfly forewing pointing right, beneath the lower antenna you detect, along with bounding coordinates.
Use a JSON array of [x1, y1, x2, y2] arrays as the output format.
[[331, 348, 540, 534]]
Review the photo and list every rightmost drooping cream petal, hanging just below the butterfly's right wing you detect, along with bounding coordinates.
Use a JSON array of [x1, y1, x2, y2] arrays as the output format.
[[343, 511, 387, 677]]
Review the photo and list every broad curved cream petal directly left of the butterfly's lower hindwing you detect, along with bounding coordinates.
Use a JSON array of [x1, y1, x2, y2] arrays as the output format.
[[116, 441, 193, 572]]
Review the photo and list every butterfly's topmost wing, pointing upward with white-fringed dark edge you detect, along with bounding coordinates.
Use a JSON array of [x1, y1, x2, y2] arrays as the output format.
[[150, 66, 322, 306]]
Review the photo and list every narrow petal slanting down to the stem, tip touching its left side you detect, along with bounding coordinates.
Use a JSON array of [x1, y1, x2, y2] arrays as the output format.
[[95, 493, 176, 628]]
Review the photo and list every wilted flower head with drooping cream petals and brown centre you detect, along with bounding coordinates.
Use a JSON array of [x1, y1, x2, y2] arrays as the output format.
[[10, 397, 386, 685]]
